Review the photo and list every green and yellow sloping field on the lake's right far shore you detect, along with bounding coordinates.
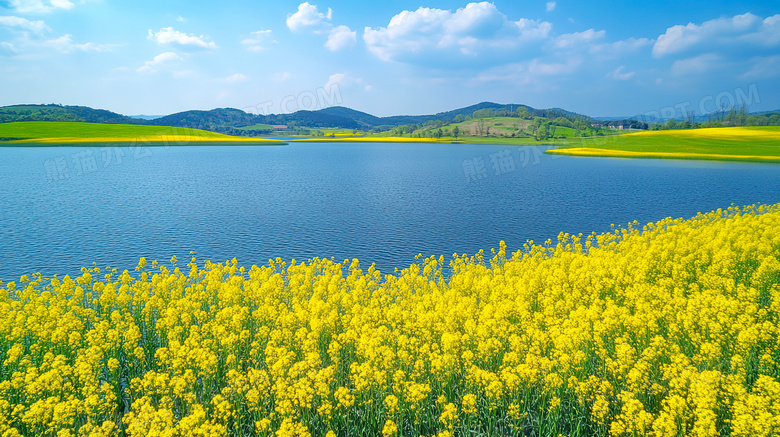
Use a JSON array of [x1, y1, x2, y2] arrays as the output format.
[[547, 126, 780, 162]]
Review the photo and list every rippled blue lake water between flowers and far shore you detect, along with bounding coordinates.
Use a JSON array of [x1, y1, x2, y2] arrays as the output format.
[[0, 143, 780, 281]]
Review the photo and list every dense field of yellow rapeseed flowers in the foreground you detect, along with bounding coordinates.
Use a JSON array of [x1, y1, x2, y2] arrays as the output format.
[[0, 205, 780, 437]]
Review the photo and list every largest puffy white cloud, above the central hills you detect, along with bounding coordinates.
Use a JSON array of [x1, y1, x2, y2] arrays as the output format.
[[363, 2, 552, 62]]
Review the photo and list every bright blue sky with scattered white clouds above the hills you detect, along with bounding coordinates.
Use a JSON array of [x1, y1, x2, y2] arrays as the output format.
[[0, 0, 780, 116]]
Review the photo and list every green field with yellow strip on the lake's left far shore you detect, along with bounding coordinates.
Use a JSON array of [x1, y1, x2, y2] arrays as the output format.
[[0, 121, 284, 146]]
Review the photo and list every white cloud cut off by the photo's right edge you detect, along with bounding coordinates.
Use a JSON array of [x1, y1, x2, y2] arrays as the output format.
[[653, 12, 780, 58]]
